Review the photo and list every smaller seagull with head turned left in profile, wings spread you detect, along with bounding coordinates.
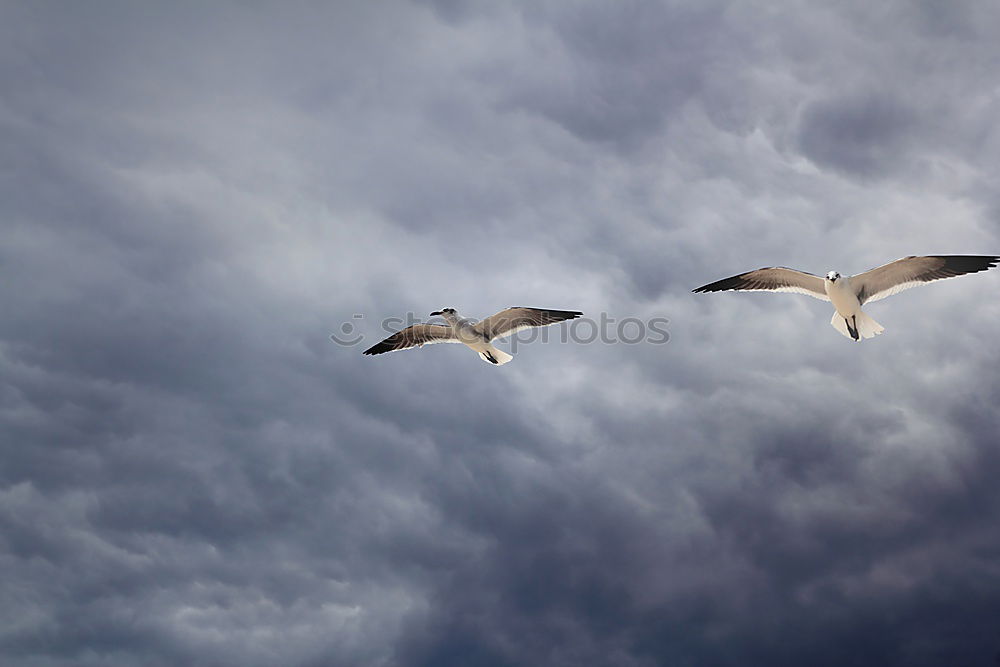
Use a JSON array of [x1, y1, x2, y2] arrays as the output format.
[[363, 306, 583, 366]]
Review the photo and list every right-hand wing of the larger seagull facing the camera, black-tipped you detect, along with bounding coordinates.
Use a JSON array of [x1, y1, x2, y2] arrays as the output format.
[[851, 255, 1000, 304]]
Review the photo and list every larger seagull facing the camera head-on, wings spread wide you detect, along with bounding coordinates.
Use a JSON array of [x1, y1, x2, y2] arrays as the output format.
[[692, 255, 1000, 342]]
